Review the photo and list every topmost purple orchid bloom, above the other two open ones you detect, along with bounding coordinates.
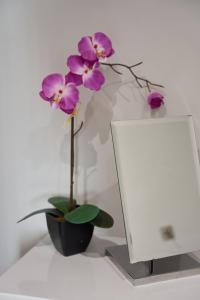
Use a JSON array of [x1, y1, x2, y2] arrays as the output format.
[[78, 32, 114, 61]]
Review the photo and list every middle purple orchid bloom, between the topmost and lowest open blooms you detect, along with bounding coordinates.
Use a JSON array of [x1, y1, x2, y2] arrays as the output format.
[[66, 55, 105, 91]]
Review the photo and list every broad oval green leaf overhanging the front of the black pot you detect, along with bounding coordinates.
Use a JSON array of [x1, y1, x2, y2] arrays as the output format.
[[64, 204, 99, 224]]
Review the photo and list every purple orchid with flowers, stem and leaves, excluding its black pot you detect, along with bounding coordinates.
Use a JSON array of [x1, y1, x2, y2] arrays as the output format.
[[19, 32, 164, 228]]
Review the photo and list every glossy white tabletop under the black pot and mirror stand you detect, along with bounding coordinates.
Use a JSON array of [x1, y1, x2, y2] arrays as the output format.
[[0, 237, 200, 300]]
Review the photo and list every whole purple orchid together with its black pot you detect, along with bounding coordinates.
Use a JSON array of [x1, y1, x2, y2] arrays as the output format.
[[18, 32, 163, 256]]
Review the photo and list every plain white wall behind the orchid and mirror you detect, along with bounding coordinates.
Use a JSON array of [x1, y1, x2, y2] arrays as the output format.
[[0, 0, 200, 272]]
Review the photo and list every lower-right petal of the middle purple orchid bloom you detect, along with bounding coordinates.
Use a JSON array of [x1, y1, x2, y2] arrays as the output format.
[[83, 69, 105, 91]]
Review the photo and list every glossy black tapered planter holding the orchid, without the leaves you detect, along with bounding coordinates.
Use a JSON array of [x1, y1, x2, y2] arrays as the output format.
[[46, 214, 94, 256]]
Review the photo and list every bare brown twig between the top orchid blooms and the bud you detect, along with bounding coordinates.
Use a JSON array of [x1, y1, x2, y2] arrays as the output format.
[[101, 61, 164, 92]]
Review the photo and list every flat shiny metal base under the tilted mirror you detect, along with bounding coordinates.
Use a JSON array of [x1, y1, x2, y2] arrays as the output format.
[[106, 245, 200, 285]]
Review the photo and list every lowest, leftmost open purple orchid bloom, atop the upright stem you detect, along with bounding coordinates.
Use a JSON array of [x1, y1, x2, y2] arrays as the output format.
[[40, 74, 79, 114]]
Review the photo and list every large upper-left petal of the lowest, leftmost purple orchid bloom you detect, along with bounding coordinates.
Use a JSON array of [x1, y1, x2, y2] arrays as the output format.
[[42, 74, 65, 98]]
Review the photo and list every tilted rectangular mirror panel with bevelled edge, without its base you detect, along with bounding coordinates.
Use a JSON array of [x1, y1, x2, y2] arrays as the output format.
[[111, 116, 200, 263]]
